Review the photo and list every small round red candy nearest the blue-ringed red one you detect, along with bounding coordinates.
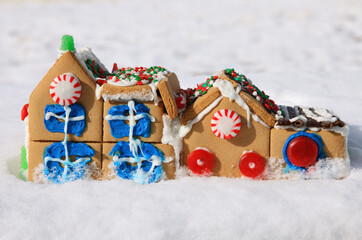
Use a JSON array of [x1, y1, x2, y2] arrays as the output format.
[[239, 152, 265, 179]]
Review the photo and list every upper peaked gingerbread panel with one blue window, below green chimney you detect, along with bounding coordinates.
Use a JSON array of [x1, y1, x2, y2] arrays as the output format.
[[29, 52, 103, 142]]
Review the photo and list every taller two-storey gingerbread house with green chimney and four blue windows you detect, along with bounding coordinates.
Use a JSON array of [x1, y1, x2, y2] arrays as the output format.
[[22, 36, 180, 183]]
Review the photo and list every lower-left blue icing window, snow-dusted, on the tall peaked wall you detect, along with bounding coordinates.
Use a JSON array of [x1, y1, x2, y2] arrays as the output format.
[[43, 142, 94, 183]]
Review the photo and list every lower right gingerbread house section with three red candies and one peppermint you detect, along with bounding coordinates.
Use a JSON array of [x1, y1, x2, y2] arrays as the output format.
[[178, 69, 349, 179]]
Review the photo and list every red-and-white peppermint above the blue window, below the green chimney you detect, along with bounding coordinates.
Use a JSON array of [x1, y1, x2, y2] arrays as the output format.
[[49, 73, 82, 106]]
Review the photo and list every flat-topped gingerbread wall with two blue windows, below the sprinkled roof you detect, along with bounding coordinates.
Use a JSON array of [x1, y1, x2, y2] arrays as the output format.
[[102, 100, 175, 183]]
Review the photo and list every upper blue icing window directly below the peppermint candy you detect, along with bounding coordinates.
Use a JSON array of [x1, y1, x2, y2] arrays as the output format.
[[44, 103, 85, 137]]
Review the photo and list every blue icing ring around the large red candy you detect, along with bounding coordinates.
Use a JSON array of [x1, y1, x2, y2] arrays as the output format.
[[283, 131, 326, 173]]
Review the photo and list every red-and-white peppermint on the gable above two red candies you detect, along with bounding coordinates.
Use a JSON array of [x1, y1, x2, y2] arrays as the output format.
[[211, 109, 241, 139]]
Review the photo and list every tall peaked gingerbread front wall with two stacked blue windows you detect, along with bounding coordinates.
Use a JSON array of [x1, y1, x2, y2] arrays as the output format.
[[28, 52, 103, 183]]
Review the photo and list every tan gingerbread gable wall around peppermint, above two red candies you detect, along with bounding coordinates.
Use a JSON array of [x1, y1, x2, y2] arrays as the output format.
[[182, 98, 270, 177]]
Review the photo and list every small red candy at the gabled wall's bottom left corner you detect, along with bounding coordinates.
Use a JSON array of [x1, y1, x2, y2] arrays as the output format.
[[187, 148, 214, 174]]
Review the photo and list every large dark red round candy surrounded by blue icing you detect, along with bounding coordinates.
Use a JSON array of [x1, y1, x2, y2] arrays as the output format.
[[287, 136, 318, 167]]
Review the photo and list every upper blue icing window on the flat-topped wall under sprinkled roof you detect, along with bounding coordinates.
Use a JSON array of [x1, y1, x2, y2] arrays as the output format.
[[108, 103, 151, 138]]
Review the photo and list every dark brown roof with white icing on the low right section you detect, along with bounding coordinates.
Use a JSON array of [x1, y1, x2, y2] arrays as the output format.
[[275, 106, 345, 129]]
